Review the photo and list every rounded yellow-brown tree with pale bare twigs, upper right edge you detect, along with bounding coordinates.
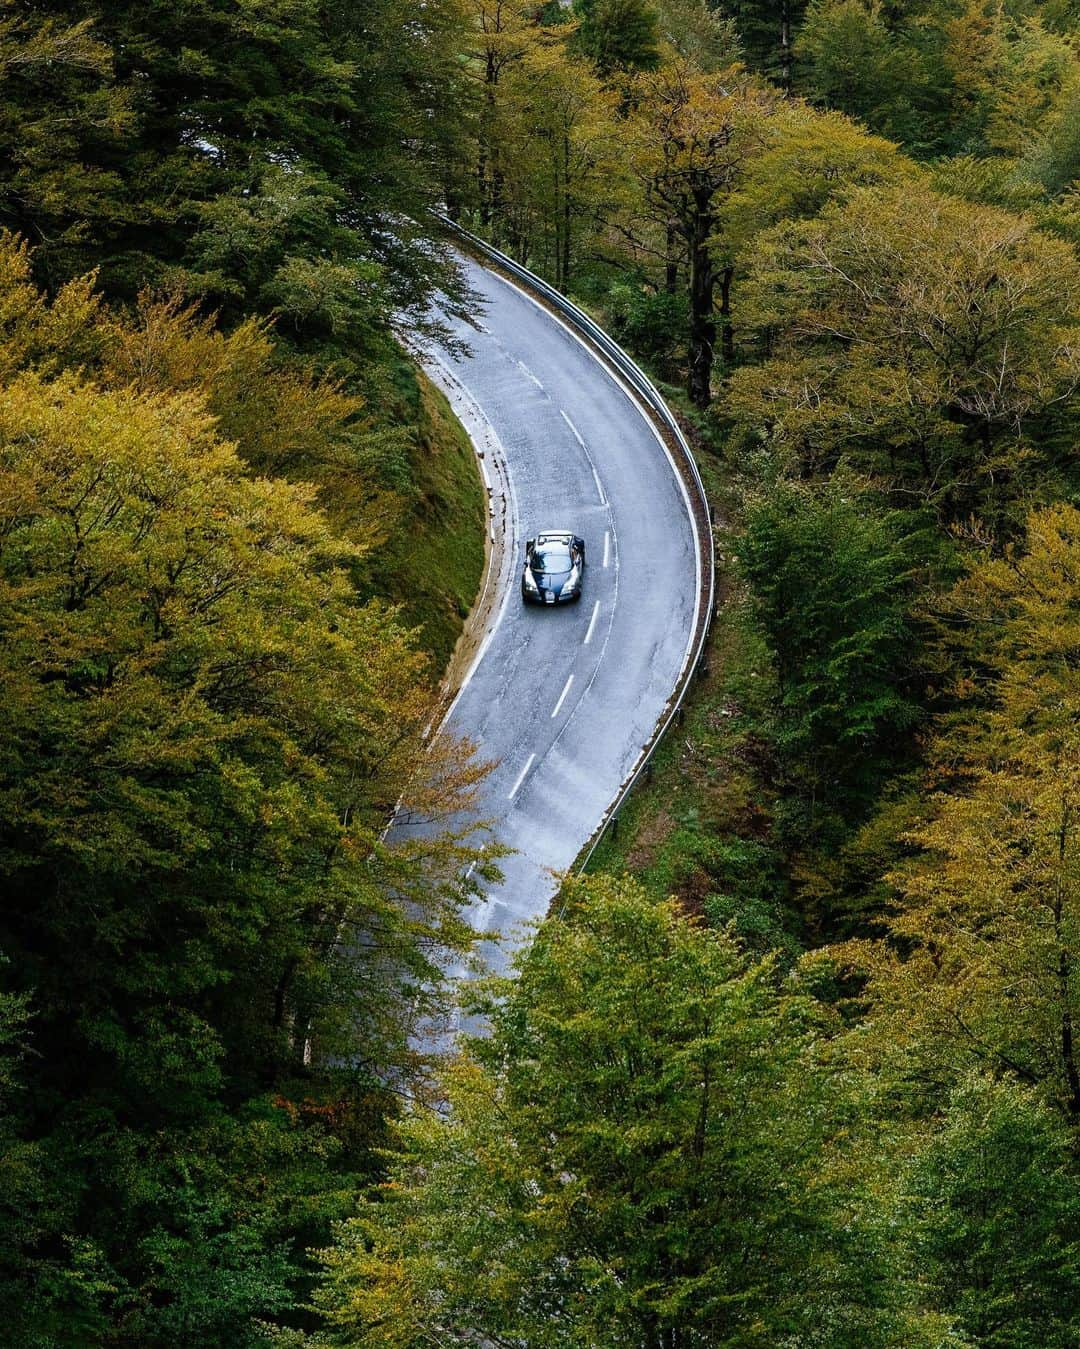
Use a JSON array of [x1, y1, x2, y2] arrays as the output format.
[[729, 185, 1080, 521]]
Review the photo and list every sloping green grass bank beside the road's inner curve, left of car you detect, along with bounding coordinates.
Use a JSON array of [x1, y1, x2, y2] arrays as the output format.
[[371, 371, 487, 673]]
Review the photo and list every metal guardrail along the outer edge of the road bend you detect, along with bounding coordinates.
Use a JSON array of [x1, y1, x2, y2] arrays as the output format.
[[438, 214, 716, 871]]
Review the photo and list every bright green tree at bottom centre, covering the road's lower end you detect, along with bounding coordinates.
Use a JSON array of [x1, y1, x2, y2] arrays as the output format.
[[307, 877, 906, 1349]]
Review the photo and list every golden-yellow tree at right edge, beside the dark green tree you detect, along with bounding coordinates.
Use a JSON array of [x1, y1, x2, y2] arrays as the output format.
[[851, 505, 1080, 1121]]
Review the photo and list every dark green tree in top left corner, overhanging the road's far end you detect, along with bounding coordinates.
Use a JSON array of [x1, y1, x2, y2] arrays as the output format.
[[0, 0, 464, 337]]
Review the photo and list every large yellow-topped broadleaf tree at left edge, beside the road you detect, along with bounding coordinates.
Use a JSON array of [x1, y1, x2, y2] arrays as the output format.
[[0, 229, 481, 1109]]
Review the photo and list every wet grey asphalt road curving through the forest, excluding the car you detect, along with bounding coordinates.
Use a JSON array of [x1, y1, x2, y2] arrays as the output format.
[[404, 260, 700, 969]]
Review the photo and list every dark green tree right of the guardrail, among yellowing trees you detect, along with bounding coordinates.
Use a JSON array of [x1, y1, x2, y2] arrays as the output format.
[[739, 478, 920, 842]]
